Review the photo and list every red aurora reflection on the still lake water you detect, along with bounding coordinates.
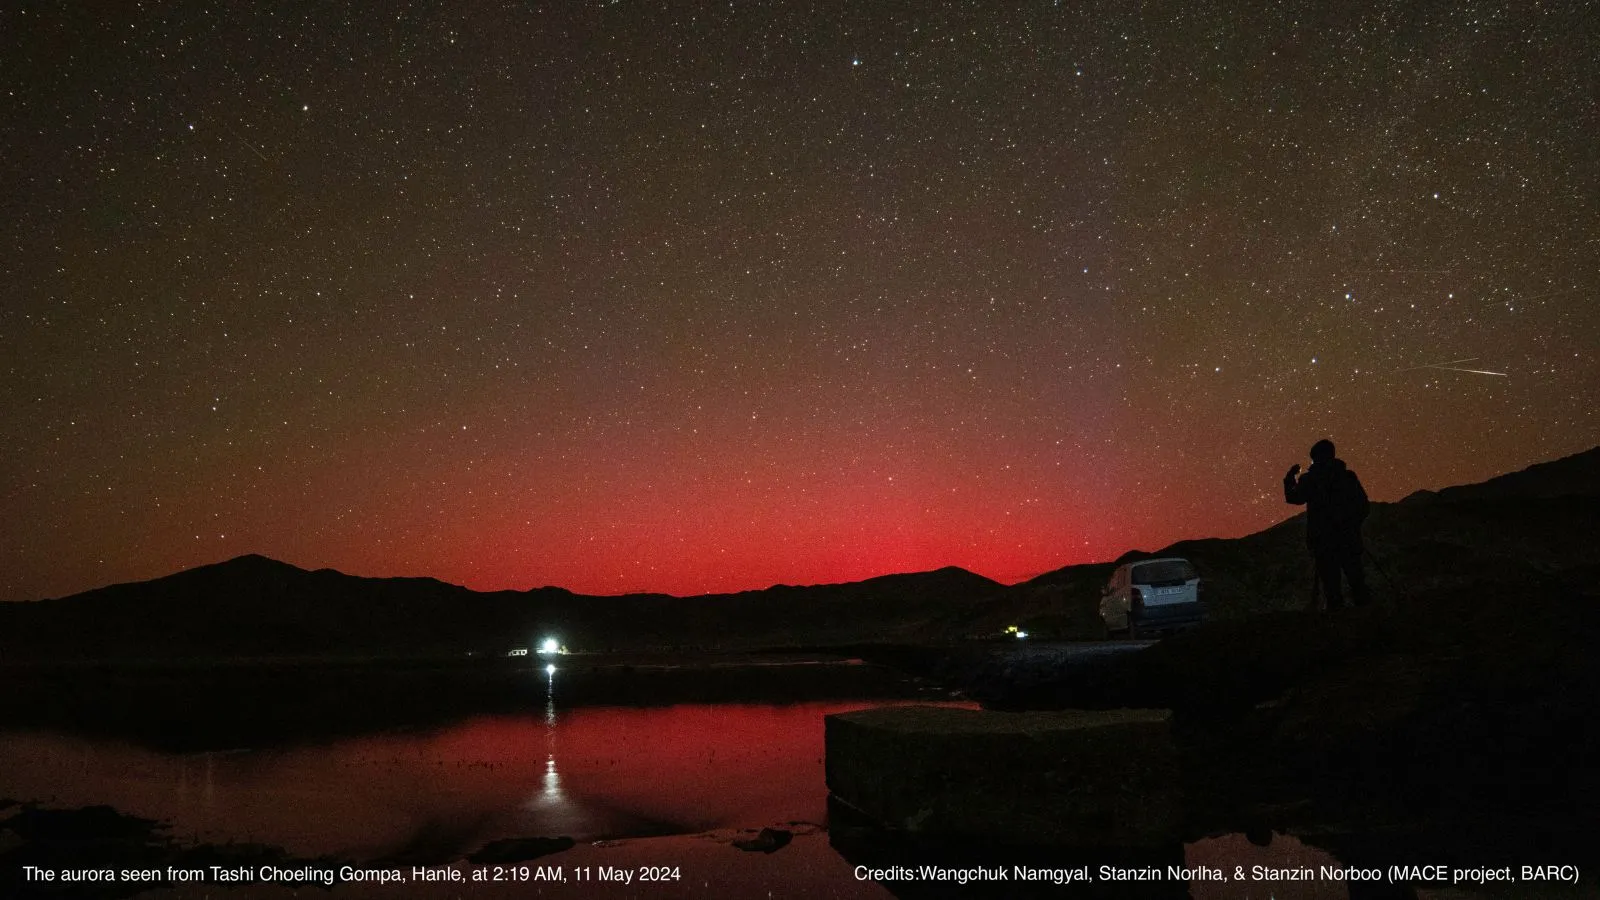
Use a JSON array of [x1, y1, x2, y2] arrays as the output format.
[[0, 703, 947, 858]]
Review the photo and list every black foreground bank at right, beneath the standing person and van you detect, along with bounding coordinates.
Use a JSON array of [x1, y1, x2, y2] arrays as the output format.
[[853, 572, 1600, 897]]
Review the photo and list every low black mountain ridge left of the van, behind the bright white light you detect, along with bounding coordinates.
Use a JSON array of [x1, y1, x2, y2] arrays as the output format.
[[0, 554, 1003, 660]]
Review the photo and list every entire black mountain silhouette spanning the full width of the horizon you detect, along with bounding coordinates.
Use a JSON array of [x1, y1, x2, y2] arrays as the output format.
[[0, 448, 1600, 661]]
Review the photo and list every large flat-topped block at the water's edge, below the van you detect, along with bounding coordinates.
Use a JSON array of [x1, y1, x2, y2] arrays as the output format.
[[826, 706, 1182, 847]]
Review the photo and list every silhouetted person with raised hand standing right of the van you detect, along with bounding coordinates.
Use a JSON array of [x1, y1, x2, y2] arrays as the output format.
[[1283, 439, 1368, 610]]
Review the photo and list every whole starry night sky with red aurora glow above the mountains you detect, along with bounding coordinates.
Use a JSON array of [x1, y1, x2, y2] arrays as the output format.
[[0, 0, 1600, 599]]
